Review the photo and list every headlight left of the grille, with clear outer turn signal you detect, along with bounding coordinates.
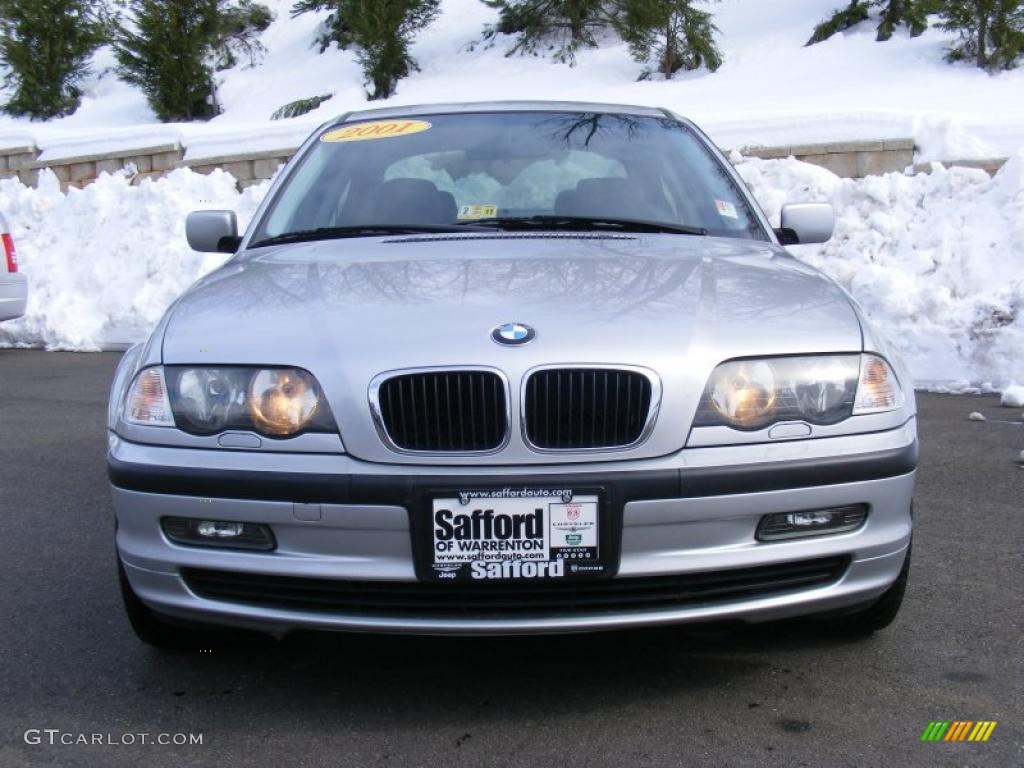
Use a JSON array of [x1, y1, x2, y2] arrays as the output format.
[[125, 366, 338, 437]]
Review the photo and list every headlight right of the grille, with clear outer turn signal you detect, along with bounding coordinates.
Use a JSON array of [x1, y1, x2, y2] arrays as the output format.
[[694, 354, 903, 430]]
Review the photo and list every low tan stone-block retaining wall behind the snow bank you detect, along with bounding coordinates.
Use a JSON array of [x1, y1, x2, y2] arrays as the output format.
[[0, 138, 1006, 189]]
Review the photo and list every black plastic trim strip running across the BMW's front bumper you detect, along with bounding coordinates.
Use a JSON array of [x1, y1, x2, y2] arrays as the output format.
[[106, 441, 918, 506]]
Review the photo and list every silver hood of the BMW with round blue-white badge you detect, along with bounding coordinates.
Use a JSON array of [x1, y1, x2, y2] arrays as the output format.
[[163, 233, 861, 463]]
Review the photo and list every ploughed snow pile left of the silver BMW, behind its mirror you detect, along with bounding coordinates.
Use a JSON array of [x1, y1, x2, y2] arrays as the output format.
[[0, 170, 269, 350]]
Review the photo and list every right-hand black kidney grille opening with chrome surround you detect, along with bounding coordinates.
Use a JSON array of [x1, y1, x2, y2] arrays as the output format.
[[523, 368, 654, 451]]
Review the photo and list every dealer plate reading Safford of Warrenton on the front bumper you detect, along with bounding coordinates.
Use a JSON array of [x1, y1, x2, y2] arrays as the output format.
[[430, 488, 604, 581]]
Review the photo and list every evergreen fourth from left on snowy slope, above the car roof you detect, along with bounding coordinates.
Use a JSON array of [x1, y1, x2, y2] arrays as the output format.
[[482, 0, 613, 65]]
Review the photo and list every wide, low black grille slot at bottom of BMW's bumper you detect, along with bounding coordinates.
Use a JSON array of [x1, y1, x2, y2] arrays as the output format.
[[182, 557, 849, 618]]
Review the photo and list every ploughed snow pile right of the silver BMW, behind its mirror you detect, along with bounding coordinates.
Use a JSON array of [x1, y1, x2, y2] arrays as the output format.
[[738, 152, 1024, 389]]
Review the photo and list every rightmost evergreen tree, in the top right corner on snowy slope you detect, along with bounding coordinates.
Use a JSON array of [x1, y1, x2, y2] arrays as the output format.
[[939, 0, 1024, 70]]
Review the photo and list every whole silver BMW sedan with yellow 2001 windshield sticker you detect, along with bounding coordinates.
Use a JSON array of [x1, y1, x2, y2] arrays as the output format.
[[108, 102, 918, 646]]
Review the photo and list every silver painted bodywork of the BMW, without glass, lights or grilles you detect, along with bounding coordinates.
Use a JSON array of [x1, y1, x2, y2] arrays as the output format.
[[109, 102, 916, 634]]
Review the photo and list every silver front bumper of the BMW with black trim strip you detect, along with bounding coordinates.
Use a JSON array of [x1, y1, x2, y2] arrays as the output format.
[[109, 420, 916, 634]]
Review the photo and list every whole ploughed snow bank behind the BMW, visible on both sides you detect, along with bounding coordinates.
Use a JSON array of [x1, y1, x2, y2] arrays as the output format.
[[0, 152, 1024, 391]]
